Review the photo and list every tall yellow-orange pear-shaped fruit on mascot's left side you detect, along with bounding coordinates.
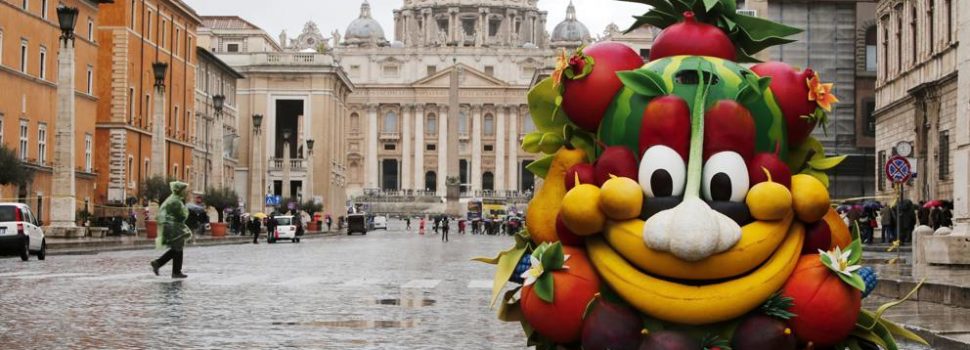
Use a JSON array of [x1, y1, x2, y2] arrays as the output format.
[[525, 147, 586, 244]]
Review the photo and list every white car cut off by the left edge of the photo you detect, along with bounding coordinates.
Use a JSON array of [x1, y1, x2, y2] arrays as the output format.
[[0, 203, 47, 261]]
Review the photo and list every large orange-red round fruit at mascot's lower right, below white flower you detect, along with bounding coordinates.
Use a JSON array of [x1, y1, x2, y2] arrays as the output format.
[[782, 254, 862, 347]]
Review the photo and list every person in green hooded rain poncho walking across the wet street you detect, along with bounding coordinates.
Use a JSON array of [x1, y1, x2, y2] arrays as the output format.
[[151, 181, 192, 278]]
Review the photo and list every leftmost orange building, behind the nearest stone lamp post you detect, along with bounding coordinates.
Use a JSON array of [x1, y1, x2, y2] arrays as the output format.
[[0, 0, 104, 224]]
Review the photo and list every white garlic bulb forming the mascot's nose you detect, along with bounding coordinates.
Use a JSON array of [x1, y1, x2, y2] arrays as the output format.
[[643, 198, 741, 261]]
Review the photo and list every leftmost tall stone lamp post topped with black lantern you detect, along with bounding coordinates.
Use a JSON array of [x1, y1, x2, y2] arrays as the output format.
[[51, 6, 78, 227]]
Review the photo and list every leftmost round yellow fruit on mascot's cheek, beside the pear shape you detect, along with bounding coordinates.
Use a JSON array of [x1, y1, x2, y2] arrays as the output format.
[[560, 184, 606, 236]]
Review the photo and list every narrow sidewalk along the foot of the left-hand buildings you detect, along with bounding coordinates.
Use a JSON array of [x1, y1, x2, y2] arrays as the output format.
[[46, 231, 340, 255]]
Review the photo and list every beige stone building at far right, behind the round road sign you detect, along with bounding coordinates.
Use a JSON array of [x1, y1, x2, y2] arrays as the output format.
[[874, 0, 970, 205]]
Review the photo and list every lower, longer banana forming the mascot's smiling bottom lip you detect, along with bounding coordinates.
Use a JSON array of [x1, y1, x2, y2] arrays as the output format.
[[586, 224, 805, 325]]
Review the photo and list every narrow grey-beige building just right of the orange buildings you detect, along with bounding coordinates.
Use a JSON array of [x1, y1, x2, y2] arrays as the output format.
[[190, 47, 244, 195]]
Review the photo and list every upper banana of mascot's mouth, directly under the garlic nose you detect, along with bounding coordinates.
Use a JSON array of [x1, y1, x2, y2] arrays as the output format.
[[605, 210, 794, 280]]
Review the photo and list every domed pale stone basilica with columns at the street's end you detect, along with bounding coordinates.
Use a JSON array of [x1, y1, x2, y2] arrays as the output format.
[[333, 0, 592, 202]]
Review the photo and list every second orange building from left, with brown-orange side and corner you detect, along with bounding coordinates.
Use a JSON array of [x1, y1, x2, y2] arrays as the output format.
[[94, 0, 200, 203]]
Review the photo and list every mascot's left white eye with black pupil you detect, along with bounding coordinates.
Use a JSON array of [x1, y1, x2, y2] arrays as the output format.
[[639, 145, 687, 198]]
